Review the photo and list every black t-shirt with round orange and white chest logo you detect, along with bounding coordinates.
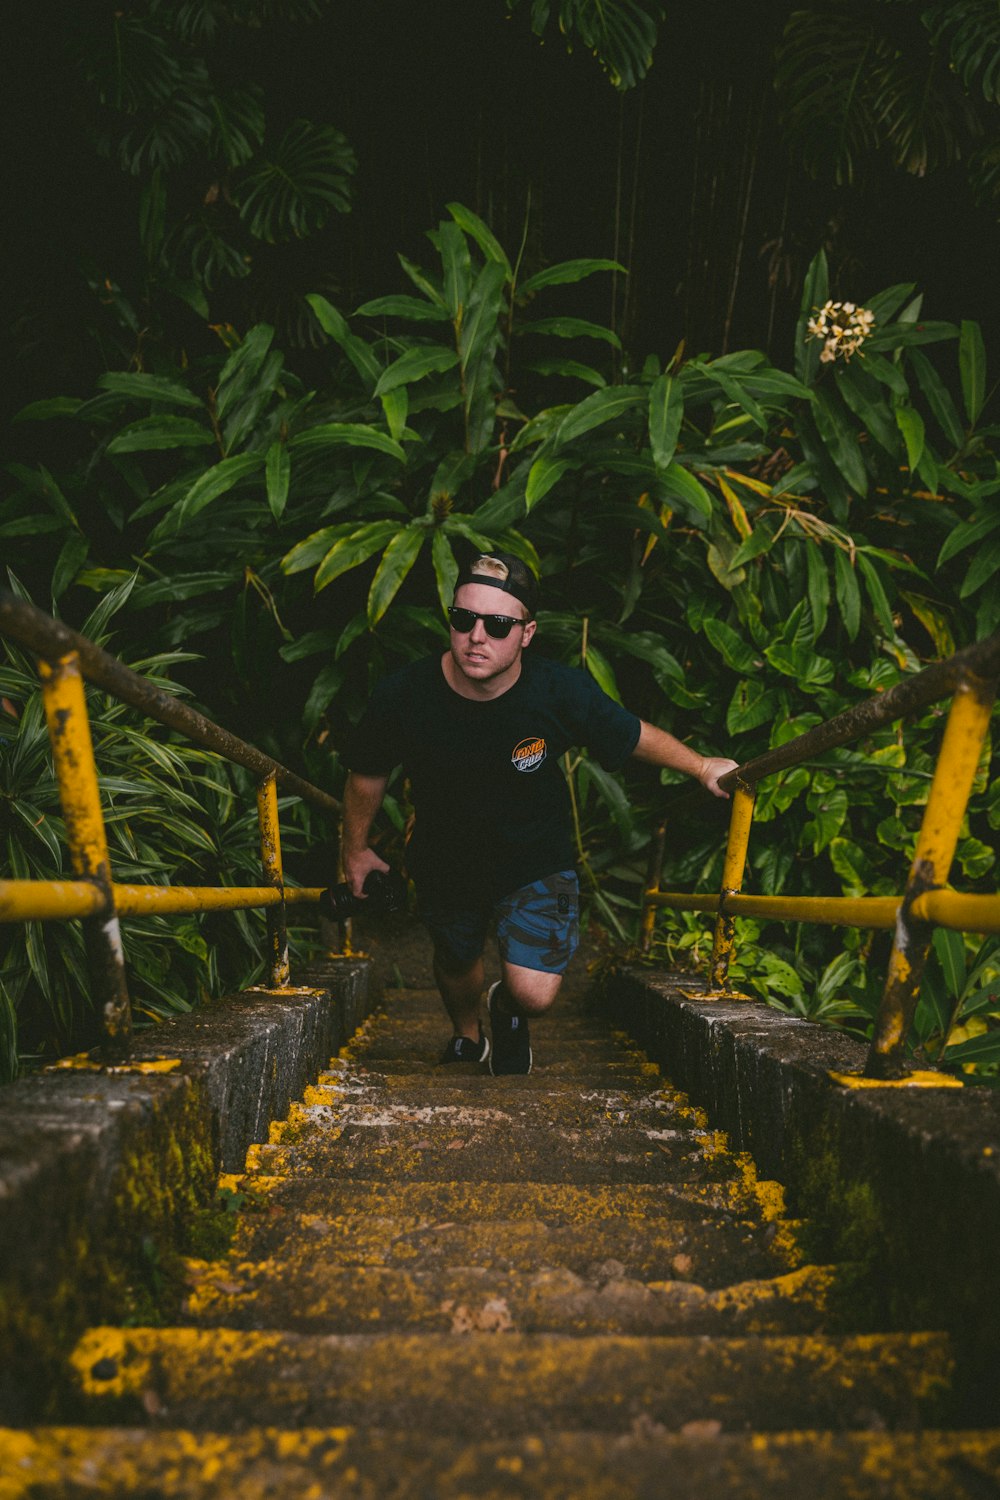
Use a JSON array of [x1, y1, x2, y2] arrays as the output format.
[[345, 653, 640, 899]]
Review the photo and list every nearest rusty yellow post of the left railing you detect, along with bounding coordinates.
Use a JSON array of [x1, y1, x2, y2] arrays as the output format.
[[37, 651, 132, 1059]]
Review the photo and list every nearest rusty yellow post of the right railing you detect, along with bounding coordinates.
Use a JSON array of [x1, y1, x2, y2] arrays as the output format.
[[865, 672, 997, 1079]]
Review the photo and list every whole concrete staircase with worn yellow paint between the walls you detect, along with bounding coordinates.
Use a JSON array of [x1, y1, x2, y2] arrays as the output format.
[[0, 990, 1000, 1500]]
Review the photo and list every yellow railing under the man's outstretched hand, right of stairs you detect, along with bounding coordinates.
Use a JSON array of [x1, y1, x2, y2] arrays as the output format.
[[642, 632, 1000, 1080]]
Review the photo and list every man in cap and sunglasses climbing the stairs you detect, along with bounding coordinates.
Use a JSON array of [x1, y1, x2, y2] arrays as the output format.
[[343, 552, 736, 1074]]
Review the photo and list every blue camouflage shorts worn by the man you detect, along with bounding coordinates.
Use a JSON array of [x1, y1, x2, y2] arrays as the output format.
[[420, 870, 580, 974]]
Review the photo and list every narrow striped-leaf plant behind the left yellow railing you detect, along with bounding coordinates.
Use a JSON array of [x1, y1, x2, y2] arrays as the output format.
[[0, 575, 301, 1079]]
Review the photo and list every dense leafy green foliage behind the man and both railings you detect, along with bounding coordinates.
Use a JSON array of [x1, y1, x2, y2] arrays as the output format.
[[0, 204, 1000, 1064]]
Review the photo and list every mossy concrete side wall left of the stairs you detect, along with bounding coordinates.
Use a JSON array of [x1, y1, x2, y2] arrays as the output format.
[[0, 959, 373, 1422]]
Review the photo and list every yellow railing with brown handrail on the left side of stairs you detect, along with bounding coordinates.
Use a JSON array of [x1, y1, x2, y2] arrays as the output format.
[[0, 588, 340, 1058]]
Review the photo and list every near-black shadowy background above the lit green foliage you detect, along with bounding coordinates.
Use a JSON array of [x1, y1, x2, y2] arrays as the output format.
[[1, 0, 997, 410]]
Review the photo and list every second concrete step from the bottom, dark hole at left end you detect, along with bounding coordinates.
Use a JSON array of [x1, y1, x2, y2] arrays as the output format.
[[70, 1328, 954, 1439]]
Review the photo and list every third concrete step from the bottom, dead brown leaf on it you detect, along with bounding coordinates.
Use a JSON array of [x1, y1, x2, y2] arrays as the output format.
[[184, 1244, 837, 1335]]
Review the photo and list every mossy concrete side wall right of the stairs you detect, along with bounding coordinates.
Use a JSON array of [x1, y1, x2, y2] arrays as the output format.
[[598, 966, 1000, 1422]]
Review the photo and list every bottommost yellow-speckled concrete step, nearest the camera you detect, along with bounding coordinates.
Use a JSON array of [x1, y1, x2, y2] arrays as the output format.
[[7, 1418, 1000, 1500]]
